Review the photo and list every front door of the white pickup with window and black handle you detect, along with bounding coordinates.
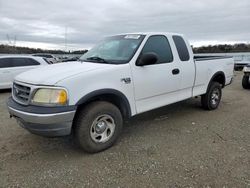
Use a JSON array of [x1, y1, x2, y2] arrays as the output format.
[[131, 35, 181, 113]]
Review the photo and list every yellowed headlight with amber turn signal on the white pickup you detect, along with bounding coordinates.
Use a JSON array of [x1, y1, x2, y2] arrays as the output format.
[[31, 88, 68, 106]]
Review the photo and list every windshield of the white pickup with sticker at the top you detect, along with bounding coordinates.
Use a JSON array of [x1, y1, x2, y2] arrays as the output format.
[[79, 34, 145, 64]]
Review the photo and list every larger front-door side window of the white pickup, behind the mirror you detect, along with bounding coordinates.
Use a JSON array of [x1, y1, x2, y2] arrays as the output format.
[[142, 35, 173, 64]]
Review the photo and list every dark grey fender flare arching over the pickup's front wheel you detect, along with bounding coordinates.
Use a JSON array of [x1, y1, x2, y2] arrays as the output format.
[[76, 89, 131, 117]]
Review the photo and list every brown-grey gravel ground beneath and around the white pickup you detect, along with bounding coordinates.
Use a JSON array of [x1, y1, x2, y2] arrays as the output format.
[[0, 73, 250, 188]]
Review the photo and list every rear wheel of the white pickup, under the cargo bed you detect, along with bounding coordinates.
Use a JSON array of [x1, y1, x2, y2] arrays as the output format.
[[201, 82, 222, 110]]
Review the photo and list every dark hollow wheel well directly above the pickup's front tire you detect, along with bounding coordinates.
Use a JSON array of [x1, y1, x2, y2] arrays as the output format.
[[77, 93, 131, 118]]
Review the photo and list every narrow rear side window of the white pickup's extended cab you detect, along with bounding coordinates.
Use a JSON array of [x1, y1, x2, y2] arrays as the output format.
[[173, 36, 190, 61]]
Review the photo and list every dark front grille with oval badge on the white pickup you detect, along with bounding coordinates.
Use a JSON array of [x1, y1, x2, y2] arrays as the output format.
[[12, 83, 31, 104]]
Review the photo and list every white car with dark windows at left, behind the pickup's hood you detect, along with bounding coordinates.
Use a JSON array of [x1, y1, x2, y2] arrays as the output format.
[[0, 55, 49, 89]]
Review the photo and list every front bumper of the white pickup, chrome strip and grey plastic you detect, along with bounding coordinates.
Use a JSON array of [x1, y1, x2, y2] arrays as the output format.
[[7, 98, 76, 137]]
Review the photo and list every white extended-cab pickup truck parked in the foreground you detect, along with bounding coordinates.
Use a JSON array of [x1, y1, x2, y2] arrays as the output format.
[[7, 33, 234, 153]]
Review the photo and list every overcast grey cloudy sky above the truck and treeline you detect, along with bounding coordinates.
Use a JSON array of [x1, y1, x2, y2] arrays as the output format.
[[0, 0, 250, 50]]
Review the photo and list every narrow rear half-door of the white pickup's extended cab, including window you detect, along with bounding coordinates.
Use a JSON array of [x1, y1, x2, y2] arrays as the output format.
[[172, 35, 195, 100]]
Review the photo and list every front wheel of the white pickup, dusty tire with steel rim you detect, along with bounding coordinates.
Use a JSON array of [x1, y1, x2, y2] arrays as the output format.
[[73, 101, 123, 153]]
